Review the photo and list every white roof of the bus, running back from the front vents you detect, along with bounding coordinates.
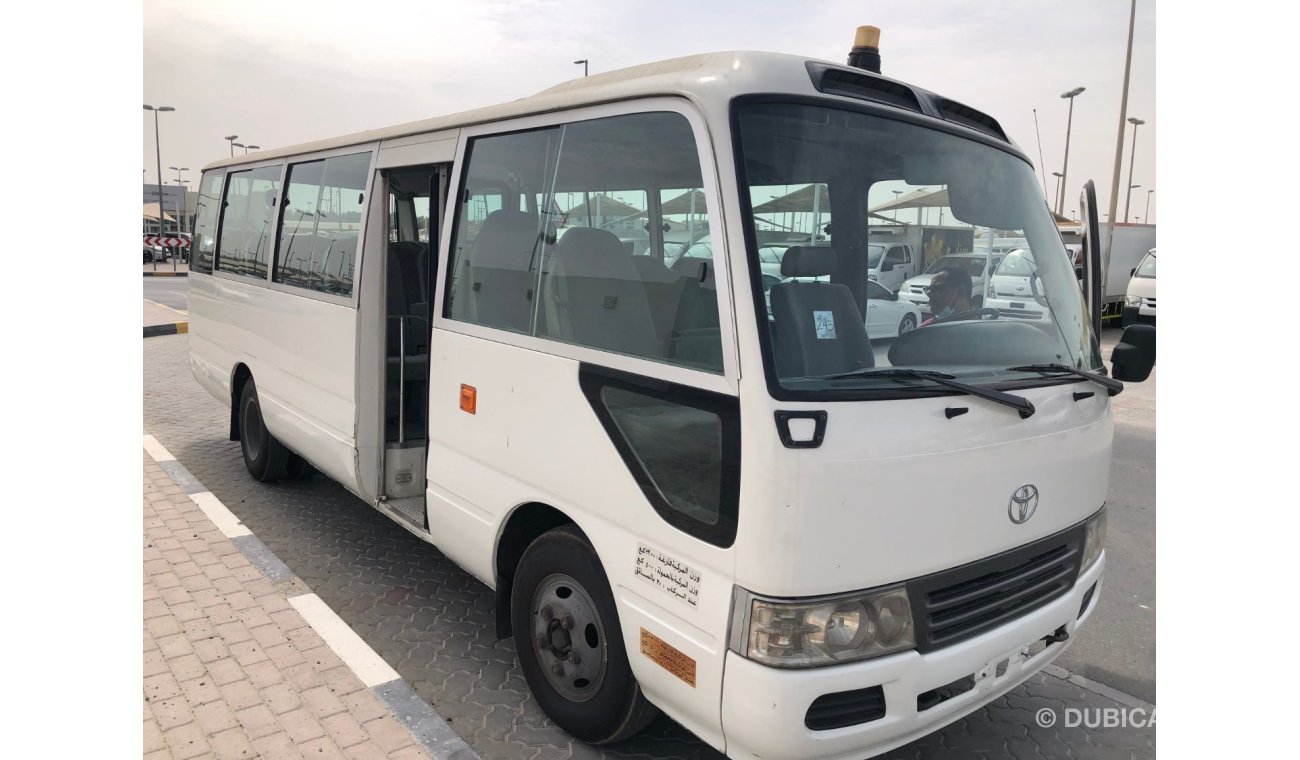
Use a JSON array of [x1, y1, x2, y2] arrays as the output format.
[[203, 51, 1019, 171]]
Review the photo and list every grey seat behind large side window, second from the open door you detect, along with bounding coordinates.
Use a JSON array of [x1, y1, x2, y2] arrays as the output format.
[[546, 227, 664, 359]]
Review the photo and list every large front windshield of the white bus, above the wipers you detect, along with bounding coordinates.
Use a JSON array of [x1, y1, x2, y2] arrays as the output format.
[[736, 101, 1102, 399]]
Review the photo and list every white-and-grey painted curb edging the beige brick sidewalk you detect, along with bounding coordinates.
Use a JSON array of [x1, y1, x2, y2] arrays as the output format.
[[144, 433, 480, 760]]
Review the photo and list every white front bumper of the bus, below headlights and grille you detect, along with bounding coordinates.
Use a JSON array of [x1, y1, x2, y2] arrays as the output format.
[[723, 552, 1106, 760]]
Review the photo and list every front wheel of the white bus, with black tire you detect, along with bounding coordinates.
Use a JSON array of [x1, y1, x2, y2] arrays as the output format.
[[510, 525, 659, 744]]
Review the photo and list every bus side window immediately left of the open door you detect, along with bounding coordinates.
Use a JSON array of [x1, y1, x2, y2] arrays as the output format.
[[274, 153, 371, 296]]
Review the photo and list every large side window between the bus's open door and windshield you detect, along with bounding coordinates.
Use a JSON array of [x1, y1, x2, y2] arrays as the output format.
[[445, 113, 722, 373]]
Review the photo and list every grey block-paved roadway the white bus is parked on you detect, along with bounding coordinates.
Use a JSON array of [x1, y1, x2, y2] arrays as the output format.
[[144, 335, 1156, 760]]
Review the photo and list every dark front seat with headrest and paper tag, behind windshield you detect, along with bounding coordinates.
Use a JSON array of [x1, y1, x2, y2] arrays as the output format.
[[772, 246, 875, 377]]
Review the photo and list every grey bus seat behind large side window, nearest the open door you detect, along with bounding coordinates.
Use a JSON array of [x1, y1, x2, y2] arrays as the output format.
[[456, 209, 542, 333]]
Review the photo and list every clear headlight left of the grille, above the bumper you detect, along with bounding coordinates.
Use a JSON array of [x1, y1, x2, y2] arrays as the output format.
[[732, 586, 917, 668]]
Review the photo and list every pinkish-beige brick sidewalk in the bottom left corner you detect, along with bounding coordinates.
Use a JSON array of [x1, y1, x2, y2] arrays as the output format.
[[144, 455, 429, 760]]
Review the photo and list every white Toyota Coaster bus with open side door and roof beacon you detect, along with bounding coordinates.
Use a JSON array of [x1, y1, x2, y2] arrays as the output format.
[[189, 27, 1154, 759]]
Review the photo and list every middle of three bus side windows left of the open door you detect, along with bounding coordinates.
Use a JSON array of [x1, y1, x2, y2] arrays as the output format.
[[217, 166, 280, 279]]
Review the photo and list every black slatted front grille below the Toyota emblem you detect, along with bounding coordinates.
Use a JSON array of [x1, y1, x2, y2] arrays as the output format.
[[907, 524, 1084, 652]]
